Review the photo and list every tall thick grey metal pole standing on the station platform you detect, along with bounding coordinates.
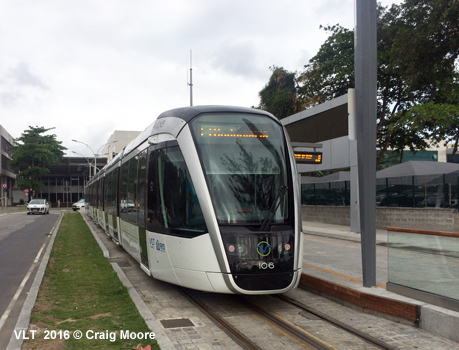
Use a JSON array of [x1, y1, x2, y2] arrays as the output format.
[[355, 0, 377, 287]]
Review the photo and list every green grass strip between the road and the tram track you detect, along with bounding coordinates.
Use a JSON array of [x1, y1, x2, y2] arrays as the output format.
[[22, 212, 159, 350]]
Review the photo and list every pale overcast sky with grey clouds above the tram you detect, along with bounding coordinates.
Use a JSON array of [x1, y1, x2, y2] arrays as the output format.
[[0, 0, 401, 156]]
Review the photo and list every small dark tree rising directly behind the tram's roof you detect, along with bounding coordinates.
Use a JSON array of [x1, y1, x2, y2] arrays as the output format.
[[258, 66, 301, 119]]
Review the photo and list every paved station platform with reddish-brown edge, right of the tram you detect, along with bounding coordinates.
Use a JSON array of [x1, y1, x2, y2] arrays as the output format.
[[301, 221, 459, 342]]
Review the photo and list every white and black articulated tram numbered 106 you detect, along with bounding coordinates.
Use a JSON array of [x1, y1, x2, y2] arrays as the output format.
[[86, 106, 303, 294]]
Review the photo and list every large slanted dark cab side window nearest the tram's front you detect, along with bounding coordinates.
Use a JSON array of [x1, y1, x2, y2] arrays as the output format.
[[157, 147, 207, 237]]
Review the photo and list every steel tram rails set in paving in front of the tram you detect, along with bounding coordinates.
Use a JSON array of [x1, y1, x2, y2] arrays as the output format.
[[181, 288, 395, 350]]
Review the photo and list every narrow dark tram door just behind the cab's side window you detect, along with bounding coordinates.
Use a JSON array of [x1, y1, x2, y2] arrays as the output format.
[[137, 150, 149, 268]]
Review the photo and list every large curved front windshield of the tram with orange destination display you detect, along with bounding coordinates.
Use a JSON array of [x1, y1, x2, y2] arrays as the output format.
[[192, 113, 288, 226]]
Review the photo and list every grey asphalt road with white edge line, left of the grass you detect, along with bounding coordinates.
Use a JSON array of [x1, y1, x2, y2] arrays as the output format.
[[0, 212, 61, 349]]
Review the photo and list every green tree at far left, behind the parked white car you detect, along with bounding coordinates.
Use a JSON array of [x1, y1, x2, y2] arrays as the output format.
[[10, 126, 66, 198]]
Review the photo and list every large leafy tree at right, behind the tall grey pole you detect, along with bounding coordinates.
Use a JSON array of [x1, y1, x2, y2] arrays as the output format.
[[261, 0, 459, 164]]
